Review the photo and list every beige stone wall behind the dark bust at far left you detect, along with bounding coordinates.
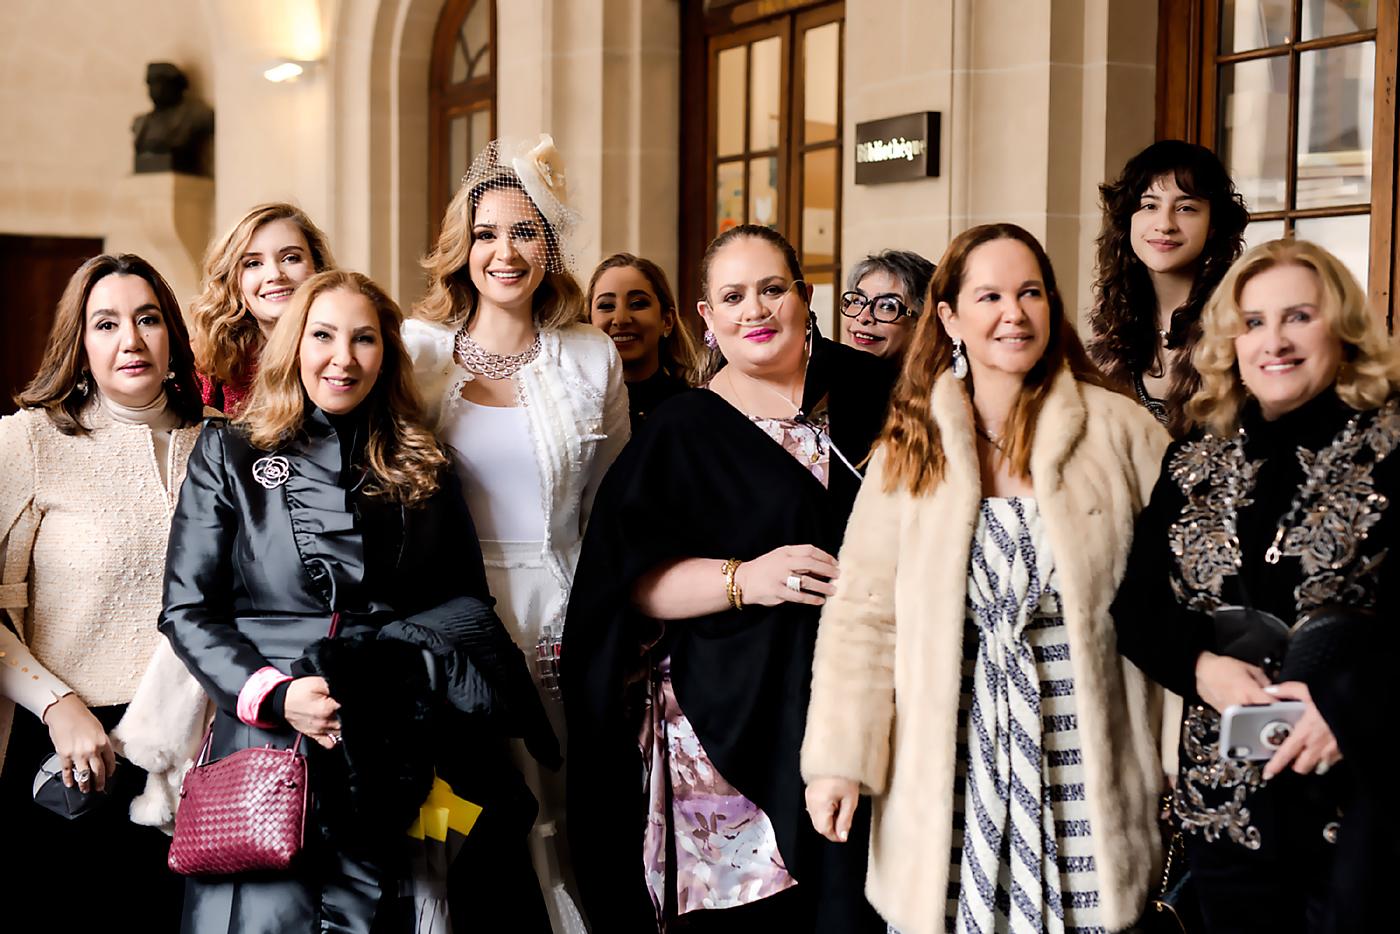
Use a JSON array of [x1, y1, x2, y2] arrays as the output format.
[[0, 0, 215, 300]]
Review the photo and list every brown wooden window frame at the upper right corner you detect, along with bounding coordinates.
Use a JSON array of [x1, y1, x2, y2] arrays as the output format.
[[1156, 0, 1400, 324]]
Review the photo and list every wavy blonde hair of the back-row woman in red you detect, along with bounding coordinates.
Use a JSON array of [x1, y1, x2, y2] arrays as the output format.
[[188, 202, 336, 384]]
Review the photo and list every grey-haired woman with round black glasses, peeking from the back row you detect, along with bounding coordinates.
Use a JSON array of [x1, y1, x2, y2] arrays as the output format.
[[841, 249, 934, 363]]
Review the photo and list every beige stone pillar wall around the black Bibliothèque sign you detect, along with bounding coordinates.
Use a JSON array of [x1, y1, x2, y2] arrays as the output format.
[[843, 0, 1156, 330]]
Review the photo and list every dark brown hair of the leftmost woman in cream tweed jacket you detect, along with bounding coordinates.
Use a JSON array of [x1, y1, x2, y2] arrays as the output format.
[[14, 253, 204, 434]]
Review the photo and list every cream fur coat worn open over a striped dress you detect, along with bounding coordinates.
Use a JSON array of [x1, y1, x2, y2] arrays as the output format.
[[802, 371, 1168, 934]]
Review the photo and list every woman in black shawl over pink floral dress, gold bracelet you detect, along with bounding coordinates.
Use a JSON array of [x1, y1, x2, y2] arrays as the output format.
[[563, 225, 890, 934]]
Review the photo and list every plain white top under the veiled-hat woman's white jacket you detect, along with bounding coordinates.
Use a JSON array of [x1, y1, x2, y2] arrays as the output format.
[[441, 399, 545, 542]]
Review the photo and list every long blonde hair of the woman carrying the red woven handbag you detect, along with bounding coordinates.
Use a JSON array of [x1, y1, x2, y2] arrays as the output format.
[[235, 269, 448, 506]]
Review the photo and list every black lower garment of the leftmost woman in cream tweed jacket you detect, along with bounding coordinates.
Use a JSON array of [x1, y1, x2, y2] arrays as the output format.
[[0, 704, 183, 934]]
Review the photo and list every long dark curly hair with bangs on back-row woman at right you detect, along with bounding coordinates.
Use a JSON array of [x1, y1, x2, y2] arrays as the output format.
[[1089, 140, 1249, 437]]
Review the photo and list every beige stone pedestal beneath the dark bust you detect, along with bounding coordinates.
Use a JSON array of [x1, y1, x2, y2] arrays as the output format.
[[106, 172, 214, 309]]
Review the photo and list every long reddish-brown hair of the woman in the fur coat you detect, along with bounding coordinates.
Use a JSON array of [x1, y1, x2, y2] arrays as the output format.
[[876, 224, 1114, 494]]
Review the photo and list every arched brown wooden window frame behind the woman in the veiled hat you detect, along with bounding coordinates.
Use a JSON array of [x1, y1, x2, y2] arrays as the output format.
[[428, 0, 498, 248]]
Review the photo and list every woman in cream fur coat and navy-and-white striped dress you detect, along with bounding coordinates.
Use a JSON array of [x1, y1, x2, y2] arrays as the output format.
[[802, 224, 1168, 934]]
